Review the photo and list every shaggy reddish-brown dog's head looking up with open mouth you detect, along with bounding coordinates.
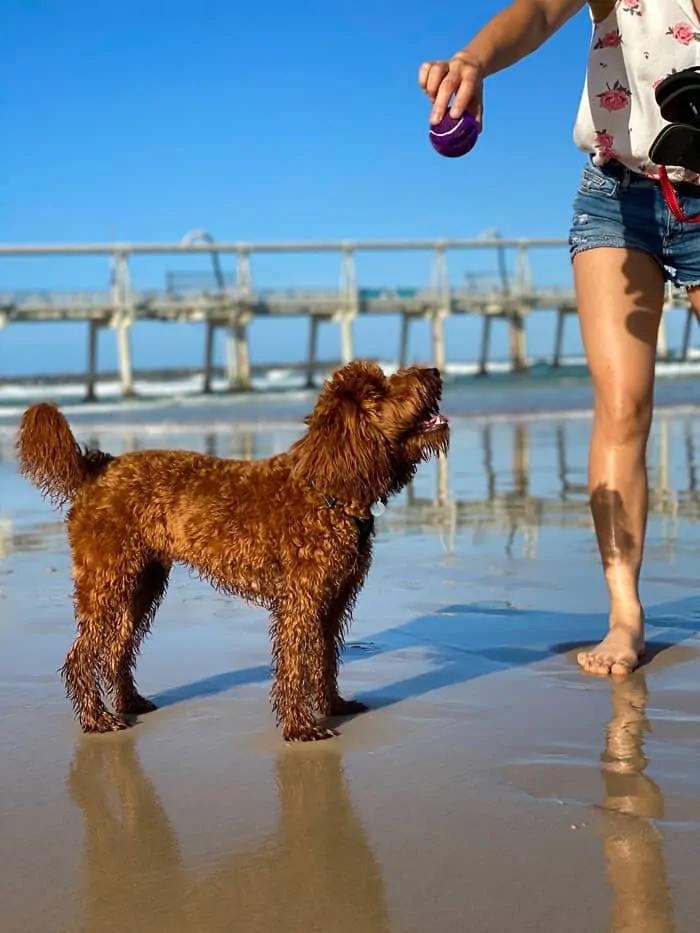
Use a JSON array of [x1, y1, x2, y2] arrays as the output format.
[[292, 361, 449, 506]]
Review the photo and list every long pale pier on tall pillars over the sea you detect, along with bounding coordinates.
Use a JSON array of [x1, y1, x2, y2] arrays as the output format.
[[0, 234, 694, 398]]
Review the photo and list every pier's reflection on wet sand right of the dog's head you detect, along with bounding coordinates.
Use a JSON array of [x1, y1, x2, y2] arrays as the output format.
[[392, 418, 700, 558]]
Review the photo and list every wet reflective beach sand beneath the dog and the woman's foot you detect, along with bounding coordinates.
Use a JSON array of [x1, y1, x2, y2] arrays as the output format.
[[0, 416, 700, 933]]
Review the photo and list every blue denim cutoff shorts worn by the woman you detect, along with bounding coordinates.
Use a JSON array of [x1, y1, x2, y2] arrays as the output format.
[[569, 160, 700, 288]]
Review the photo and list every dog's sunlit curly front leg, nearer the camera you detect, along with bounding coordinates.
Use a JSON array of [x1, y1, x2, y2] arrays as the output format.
[[270, 581, 335, 742]]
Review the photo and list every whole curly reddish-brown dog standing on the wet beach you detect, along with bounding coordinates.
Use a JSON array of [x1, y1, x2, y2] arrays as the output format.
[[17, 361, 449, 741]]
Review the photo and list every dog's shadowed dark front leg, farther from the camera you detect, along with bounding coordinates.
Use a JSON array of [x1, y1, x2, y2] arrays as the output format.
[[317, 562, 368, 716]]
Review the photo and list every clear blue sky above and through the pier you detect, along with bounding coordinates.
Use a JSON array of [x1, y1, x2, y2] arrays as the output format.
[[0, 0, 590, 371]]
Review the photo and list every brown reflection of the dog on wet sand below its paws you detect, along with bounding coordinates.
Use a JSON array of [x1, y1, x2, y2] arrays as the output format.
[[68, 733, 389, 933]]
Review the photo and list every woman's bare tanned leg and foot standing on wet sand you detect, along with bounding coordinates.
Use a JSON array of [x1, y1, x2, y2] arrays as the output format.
[[574, 247, 664, 675]]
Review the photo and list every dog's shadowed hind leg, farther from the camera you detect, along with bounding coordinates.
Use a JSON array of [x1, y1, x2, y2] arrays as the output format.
[[101, 560, 171, 715]]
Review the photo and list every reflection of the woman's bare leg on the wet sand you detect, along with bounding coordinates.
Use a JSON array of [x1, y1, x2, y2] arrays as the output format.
[[601, 670, 675, 933]]
